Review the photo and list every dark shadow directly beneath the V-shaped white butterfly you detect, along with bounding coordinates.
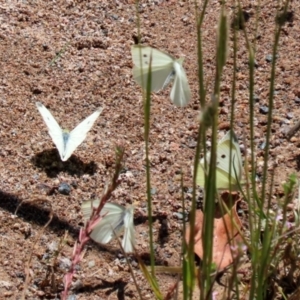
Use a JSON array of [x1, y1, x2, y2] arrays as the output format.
[[31, 149, 97, 178]]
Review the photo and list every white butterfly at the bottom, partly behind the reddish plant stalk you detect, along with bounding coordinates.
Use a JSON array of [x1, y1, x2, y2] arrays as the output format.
[[82, 200, 135, 253]]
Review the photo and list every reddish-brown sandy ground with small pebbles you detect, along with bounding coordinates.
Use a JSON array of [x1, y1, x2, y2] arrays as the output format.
[[0, 0, 300, 299]]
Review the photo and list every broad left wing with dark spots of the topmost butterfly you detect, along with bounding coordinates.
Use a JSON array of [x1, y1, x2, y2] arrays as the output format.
[[131, 45, 174, 92]]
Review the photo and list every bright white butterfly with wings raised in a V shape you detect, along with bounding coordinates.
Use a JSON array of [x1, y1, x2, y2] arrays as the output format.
[[36, 102, 103, 161]]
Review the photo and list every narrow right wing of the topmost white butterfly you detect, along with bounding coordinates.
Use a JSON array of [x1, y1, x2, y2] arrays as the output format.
[[170, 61, 191, 107]]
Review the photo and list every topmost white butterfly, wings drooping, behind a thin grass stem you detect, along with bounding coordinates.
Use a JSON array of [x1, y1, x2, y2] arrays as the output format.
[[131, 45, 191, 107]]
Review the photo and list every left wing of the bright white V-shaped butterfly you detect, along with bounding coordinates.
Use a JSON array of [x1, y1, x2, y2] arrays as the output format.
[[36, 102, 65, 159]]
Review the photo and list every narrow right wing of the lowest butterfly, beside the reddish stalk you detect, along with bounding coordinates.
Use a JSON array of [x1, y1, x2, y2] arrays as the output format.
[[122, 206, 135, 253]]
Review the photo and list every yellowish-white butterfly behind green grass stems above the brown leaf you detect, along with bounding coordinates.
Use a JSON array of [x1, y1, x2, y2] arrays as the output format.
[[196, 130, 243, 190]]
